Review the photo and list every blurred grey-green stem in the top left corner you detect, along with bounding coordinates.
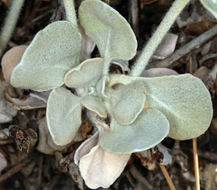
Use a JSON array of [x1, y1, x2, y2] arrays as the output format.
[[0, 0, 24, 56]]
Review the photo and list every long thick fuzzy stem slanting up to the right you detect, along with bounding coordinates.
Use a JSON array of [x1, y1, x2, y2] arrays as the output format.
[[130, 0, 190, 76]]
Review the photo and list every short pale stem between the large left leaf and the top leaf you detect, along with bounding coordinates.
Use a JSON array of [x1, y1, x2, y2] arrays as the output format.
[[63, 0, 77, 26]]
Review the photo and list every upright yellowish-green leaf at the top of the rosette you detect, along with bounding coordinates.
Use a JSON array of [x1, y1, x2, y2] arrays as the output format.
[[79, 0, 137, 60]]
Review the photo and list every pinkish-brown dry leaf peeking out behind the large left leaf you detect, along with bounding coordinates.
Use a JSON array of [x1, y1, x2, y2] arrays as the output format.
[[1, 45, 27, 82]]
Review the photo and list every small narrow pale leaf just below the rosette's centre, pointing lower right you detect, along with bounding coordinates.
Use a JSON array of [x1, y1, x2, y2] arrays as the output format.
[[81, 96, 107, 118]]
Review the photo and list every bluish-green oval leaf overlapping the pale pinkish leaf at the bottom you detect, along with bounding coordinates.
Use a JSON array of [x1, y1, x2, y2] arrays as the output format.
[[99, 109, 169, 153]]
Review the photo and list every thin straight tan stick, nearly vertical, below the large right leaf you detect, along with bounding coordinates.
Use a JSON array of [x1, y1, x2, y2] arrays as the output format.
[[192, 138, 200, 190]]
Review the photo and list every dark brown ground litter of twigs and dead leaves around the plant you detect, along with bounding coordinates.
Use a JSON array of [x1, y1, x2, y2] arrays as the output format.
[[0, 0, 217, 190]]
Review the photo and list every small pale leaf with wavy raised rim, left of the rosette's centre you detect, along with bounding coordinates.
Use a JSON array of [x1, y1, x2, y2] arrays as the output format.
[[64, 58, 103, 88]]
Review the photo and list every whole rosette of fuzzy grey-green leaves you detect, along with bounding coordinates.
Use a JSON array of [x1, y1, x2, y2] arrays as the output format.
[[4, 0, 212, 188]]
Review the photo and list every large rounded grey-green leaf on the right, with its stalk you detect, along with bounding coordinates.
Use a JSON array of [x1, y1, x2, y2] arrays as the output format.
[[110, 74, 213, 140]]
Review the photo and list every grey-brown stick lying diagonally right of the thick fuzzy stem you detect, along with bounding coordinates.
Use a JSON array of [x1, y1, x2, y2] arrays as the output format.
[[149, 25, 217, 68]]
